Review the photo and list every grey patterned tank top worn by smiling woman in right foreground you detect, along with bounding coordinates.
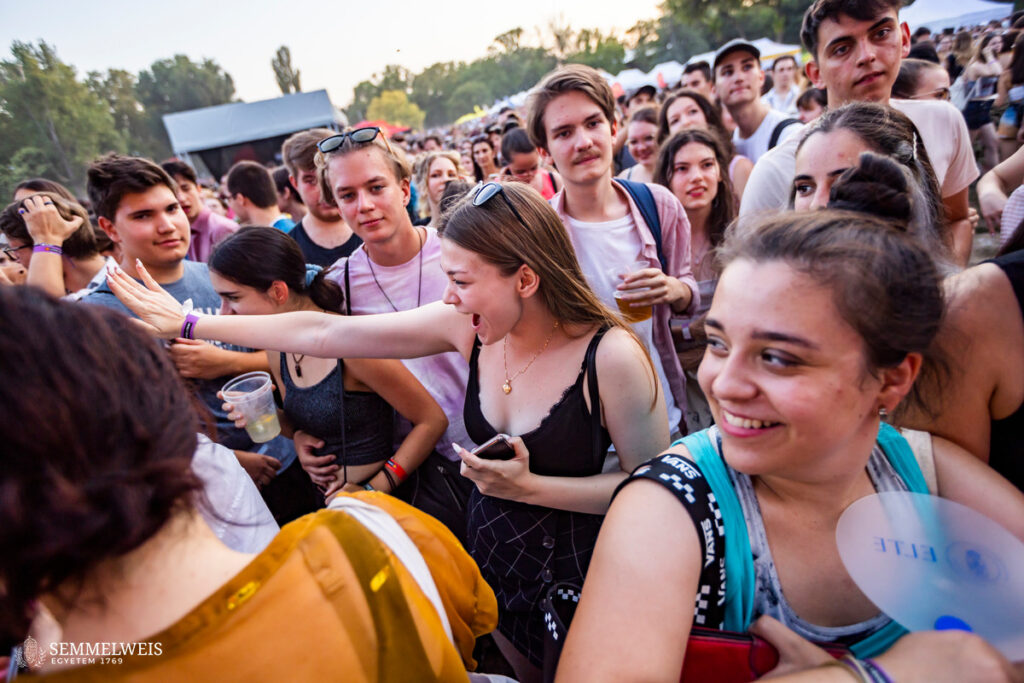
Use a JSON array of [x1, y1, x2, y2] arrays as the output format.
[[712, 427, 907, 643]]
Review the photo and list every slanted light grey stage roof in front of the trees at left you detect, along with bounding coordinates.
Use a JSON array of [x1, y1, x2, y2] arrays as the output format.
[[164, 90, 345, 155]]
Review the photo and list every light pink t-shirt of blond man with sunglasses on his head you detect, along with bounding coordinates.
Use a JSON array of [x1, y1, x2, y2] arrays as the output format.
[[328, 227, 473, 460]]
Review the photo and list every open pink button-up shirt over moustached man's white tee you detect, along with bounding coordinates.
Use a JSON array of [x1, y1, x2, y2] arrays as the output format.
[[550, 182, 700, 429]]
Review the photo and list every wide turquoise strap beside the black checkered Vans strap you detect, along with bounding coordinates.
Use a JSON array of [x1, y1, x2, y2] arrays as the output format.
[[673, 429, 754, 633]]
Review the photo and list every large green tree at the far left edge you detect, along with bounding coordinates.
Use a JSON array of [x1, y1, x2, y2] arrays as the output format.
[[0, 41, 124, 197]]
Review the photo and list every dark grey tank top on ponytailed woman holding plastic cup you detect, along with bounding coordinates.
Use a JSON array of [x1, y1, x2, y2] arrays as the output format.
[[281, 353, 394, 466]]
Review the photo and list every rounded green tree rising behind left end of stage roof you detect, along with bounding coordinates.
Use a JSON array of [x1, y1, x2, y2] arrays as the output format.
[[135, 54, 234, 148]]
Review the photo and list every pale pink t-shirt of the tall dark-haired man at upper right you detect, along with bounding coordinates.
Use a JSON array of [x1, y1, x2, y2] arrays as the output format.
[[739, 99, 978, 216]]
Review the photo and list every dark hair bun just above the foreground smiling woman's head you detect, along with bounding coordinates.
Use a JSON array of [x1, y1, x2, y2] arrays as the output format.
[[828, 152, 912, 229]]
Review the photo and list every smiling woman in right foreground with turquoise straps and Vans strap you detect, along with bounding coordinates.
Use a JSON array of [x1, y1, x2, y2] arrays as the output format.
[[558, 210, 1024, 683]]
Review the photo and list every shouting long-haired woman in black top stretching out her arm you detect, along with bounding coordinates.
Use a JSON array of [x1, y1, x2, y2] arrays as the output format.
[[112, 178, 669, 680]]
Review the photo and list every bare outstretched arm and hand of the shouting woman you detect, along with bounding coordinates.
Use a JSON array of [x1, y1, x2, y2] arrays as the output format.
[[108, 263, 473, 358]]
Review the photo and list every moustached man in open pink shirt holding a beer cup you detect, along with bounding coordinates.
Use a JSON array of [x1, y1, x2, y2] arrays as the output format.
[[526, 65, 699, 434]]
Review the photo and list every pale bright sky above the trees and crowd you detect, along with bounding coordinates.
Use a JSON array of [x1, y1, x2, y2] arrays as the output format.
[[0, 0, 658, 108]]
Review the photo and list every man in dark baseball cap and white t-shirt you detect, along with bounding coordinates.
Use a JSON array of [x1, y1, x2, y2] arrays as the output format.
[[714, 39, 803, 164]]
